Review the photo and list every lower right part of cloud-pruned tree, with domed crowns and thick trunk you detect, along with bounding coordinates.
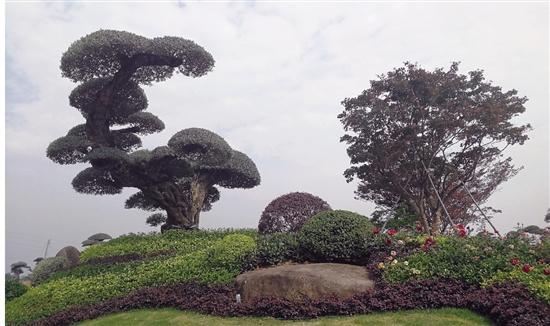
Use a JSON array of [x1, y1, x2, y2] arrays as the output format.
[[126, 128, 260, 231]]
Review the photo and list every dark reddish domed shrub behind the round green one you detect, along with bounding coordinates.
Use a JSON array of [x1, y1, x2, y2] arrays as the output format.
[[258, 192, 331, 234]]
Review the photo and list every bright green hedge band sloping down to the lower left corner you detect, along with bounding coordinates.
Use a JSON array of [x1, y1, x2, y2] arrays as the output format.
[[6, 234, 256, 324]]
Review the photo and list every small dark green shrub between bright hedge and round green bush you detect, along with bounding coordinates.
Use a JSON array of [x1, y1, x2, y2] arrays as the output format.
[[256, 233, 300, 266]]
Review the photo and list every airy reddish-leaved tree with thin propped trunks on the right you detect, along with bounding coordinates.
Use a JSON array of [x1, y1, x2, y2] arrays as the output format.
[[338, 63, 530, 234]]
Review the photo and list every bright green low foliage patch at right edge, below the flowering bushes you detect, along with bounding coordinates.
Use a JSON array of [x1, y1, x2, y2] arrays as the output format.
[[483, 264, 550, 304]]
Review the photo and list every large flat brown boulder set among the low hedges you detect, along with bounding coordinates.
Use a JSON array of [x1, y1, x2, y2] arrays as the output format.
[[237, 264, 374, 302]]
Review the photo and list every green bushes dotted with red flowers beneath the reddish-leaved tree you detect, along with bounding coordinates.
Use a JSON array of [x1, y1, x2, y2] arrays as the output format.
[[383, 236, 537, 284]]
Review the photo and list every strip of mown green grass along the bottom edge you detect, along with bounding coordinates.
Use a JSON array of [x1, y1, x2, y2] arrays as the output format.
[[79, 308, 492, 326]]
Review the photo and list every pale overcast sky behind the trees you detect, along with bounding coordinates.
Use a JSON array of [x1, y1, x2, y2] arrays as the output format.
[[5, 2, 549, 272]]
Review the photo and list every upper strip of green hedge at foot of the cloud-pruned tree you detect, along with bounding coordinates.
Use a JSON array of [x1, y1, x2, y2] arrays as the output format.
[[80, 229, 256, 262]]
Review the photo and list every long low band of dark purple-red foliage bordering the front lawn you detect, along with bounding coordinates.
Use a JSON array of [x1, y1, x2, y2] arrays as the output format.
[[34, 280, 550, 325]]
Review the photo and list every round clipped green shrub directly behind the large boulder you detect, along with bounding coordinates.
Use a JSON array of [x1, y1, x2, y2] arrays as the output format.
[[298, 210, 374, 263]]
